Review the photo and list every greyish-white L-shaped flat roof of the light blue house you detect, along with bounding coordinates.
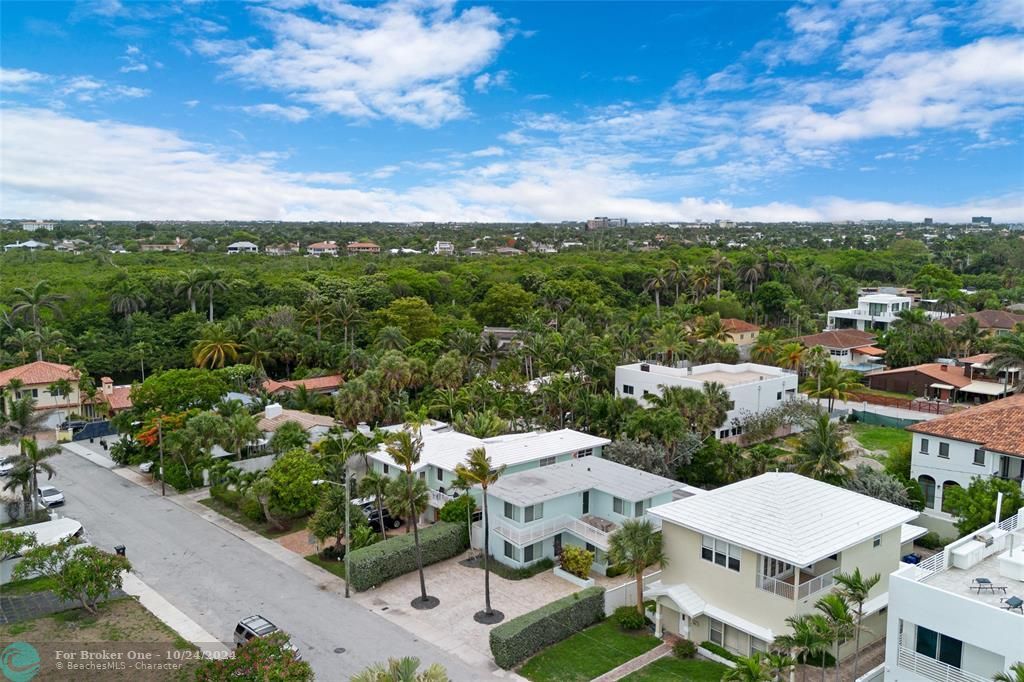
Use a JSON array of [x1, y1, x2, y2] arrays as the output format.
[[487, 457, 680, 507]]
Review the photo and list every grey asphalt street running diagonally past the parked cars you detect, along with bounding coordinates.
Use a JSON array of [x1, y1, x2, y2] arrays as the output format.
[[51, 453, 492, 682]]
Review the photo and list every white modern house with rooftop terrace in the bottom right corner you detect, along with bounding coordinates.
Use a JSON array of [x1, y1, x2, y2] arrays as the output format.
[[869, 511, 1024, 682]]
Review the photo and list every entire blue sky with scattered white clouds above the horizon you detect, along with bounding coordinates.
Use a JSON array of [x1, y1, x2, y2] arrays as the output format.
[[0, 0, 1024, 221]]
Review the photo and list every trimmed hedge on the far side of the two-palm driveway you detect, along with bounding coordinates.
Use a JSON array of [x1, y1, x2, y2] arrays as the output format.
[[348, 521, 468, 592]]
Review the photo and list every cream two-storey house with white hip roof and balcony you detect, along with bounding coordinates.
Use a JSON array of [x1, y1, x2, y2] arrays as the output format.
[[644, 473, 925, 657]]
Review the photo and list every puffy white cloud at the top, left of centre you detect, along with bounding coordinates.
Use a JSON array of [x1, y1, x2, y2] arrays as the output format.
[[196, 0, 505, 128]]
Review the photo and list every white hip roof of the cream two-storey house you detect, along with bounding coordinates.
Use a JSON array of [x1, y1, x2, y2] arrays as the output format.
[[650, 472, 918, 566]]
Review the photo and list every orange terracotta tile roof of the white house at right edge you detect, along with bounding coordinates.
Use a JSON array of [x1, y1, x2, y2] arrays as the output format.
[[907, 394, 1024, 456]]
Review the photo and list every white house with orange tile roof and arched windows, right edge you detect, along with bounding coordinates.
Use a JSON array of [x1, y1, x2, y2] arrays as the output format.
[[907, 394, 1024, 529]]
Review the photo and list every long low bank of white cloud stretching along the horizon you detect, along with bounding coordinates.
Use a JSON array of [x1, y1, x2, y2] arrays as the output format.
[[0, 109, 1024, 221]]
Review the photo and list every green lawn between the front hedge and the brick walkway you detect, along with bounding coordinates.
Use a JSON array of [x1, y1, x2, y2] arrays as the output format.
[[519, 620, 662, 682]]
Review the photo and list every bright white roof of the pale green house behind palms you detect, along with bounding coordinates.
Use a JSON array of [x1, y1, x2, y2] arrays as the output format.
[[371, 429, 611, 471]]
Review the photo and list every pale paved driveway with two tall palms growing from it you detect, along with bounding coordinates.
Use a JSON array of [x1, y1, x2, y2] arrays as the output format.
[[355, 554, 579, 671]]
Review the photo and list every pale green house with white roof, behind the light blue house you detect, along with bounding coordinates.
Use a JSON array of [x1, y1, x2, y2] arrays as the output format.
[[368, 423, 611, 520]]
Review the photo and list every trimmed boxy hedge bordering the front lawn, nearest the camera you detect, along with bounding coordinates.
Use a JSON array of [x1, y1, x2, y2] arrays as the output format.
[[490, 587, 604, 670]]
